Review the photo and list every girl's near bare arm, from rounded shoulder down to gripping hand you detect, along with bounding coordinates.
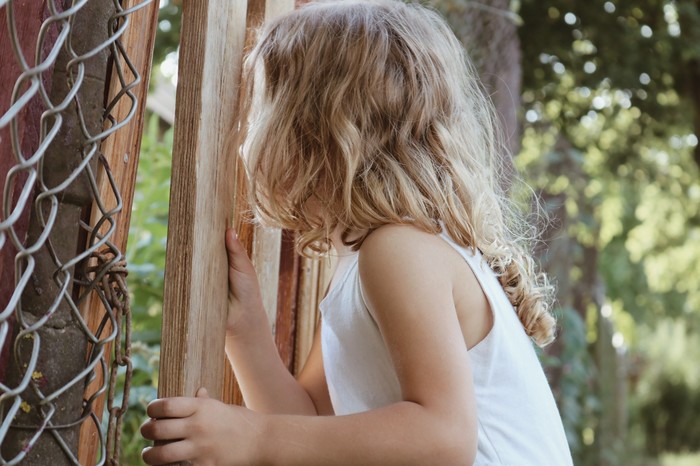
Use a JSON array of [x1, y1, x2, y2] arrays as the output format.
[[143, 226, 481, 466]]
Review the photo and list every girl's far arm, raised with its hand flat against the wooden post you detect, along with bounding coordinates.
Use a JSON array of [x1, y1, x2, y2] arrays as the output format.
[[226, 230, 332, 415]]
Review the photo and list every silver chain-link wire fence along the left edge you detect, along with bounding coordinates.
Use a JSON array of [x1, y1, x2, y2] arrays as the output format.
[[0, 0, 150, 465]]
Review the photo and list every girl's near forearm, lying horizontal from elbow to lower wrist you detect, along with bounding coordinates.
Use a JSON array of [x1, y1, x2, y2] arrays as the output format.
[[253, 401, 476, 466]]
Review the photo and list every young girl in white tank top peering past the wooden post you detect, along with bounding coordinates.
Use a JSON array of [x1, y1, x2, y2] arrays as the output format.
[[142, 0, 571, 466]]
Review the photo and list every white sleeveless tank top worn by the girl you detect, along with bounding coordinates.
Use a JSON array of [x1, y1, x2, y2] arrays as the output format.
[[320, 232, 573, 466]]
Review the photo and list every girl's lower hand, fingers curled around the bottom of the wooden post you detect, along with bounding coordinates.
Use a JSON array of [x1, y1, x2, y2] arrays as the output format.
[[141, 388, 263, 466]]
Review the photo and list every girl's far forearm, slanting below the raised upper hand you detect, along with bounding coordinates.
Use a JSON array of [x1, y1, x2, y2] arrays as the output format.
[[226, 313, 316, 416]]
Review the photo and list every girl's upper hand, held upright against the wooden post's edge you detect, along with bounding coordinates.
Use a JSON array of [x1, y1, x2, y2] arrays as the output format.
[[226, 228, 264, 335]]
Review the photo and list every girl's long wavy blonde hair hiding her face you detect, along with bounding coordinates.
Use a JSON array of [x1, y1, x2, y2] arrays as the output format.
[[241, 0, 555, 346]]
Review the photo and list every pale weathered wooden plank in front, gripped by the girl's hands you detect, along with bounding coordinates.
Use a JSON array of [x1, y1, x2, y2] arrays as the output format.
[[158, 0, 247, 404]]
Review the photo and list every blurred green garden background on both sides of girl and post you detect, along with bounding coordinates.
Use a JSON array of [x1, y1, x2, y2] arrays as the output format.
[[123, 0, 700, 466]]
